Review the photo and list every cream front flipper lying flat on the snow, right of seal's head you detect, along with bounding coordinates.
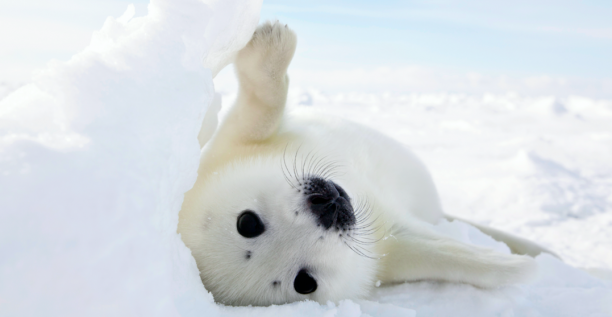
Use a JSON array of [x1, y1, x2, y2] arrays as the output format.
[[379, 225, 537, 288]]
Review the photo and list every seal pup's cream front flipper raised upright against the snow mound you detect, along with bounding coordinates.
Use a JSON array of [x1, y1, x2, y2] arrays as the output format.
[[219, 22, 297, 144]]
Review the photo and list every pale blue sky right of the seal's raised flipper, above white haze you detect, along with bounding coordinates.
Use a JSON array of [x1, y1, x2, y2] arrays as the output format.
[[262, 0, 612, 77]]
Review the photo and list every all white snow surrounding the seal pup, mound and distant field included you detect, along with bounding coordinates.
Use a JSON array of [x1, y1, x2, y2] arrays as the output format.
[[0, 0, 612, 317]]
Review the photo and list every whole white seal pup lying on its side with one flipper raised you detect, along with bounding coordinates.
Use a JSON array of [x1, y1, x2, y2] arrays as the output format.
[[178, 22, 541, 305]]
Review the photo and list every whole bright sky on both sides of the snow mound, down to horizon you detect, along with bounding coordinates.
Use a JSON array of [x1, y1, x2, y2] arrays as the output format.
[[0, 0, 612, 98]]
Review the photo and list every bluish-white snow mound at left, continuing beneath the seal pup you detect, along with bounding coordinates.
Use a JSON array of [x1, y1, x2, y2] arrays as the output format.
[[0, 0, 612, 316]]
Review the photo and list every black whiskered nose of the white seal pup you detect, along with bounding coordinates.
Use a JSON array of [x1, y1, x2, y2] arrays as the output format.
[[304, 177, 356, 230]]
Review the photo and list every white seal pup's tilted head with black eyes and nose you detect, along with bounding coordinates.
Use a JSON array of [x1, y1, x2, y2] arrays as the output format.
[[179, 154, 376, 305]]
